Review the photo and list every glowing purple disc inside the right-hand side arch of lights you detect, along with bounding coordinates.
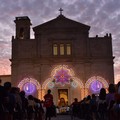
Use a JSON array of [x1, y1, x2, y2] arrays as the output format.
[[90, 80, 103, 93]]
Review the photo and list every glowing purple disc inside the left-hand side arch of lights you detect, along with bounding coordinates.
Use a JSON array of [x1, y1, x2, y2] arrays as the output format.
[[23, 82, 36, 94]]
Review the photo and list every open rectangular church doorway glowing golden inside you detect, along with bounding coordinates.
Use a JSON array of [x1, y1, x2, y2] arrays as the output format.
[[58, 89, 68, 107]]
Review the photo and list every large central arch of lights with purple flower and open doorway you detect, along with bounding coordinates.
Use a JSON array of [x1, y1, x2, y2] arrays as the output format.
[[42, 65, 84, 105]]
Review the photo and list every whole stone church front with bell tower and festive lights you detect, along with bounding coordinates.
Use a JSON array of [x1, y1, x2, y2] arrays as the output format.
[[11, 14, 114, 105]]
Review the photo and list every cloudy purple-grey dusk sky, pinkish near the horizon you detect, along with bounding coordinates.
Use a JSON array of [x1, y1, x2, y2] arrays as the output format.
[[0, 0, 120, 83]]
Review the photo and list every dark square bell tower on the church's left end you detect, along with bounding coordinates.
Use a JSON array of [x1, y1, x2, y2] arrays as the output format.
[[14, 16, 32, 39]]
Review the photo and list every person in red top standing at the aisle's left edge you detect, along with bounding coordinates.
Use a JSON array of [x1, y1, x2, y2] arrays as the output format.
[[44, 89, 54, 120]]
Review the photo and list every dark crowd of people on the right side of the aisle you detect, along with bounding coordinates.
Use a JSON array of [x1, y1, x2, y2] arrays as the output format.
[[71, 82, 120, 120]]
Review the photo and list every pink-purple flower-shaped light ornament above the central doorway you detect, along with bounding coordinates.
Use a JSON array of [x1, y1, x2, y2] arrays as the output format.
[[54, 69, 71, 85]]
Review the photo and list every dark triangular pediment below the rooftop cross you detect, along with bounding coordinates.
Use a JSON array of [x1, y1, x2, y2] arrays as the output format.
[[33, 15, 90, 32]]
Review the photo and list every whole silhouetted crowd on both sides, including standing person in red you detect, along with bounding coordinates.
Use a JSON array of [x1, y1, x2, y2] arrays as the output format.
[[0, 78, 120, 120]]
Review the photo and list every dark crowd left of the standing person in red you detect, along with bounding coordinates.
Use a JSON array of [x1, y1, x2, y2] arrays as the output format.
[[0, 80, 44, 120]]
